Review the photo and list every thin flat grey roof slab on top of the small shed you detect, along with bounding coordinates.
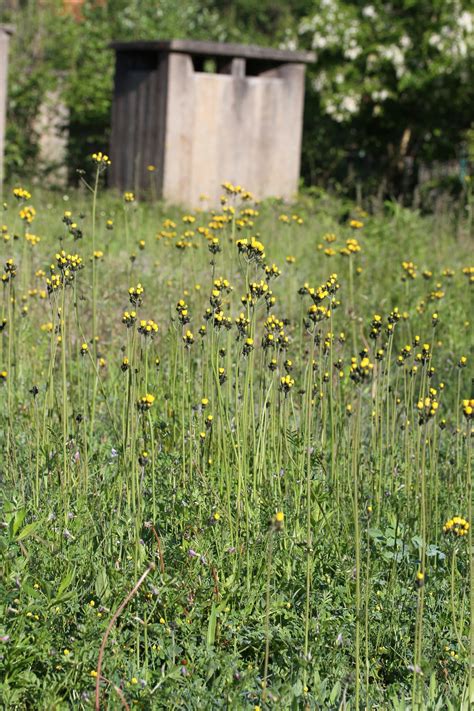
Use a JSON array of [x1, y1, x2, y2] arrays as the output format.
[[110, 39, 316, 63]]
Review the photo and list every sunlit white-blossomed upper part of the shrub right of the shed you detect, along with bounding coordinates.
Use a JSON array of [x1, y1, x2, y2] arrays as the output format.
[[298, 0, 474, 122]]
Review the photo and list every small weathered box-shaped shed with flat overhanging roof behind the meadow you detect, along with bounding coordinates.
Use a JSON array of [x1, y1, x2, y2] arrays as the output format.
[[110, 40, 314, 206]]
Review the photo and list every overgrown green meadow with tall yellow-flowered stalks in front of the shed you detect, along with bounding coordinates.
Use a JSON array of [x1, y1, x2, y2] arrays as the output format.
[[0, 164, 474, 711]]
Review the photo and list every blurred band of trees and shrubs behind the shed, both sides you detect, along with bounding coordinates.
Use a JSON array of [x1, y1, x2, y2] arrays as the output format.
[[0, 0, 474, 199]]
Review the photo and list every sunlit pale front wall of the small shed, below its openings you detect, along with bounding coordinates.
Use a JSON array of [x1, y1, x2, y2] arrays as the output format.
[[163, 53, 305, 206]]
